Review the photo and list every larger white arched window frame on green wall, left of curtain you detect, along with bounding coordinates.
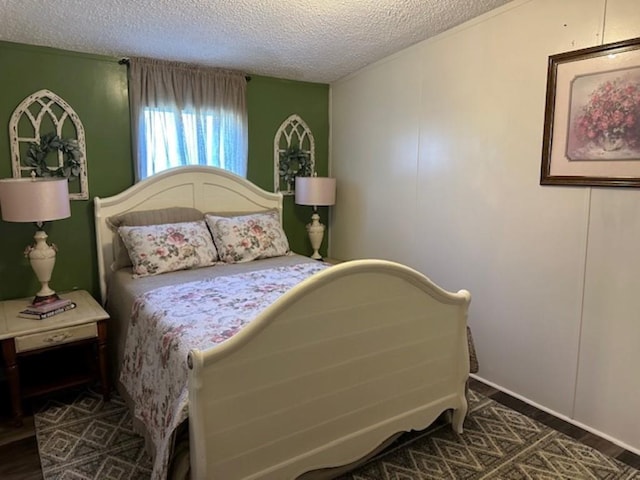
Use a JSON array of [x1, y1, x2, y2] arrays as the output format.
[[9, 89, 89, 200]]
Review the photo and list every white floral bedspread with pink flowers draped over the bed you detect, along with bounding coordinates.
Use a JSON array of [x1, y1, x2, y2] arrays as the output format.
[[120, 263, 327, 479]]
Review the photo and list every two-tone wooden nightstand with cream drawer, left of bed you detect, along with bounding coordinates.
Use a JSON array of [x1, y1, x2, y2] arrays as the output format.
[[0, 290, 110, 426]]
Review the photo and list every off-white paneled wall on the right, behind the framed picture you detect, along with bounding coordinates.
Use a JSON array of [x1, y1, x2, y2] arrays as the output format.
[[330, 0, 640, 452]]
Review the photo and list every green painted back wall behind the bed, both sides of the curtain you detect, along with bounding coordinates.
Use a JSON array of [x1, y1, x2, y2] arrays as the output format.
[[0, 42, 329, 300]]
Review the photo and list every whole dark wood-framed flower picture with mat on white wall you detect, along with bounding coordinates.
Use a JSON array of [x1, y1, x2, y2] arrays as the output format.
[[540, 38, 640, 187]]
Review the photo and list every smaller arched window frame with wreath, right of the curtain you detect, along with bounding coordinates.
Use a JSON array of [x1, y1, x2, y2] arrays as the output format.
[[273, 114, 316, 195]]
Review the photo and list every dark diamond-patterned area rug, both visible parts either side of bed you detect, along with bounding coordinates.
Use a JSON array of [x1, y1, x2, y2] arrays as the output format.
[[34, 390, 640, 480]]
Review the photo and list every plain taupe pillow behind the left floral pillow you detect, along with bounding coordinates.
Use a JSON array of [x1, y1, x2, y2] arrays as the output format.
[[106, 207, 204, 271]]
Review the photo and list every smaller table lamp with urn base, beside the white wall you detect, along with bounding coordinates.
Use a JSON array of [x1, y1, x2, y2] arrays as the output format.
[[295, 176, 336, 260]]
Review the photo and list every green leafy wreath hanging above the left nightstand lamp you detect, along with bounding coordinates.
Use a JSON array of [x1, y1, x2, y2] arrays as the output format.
[[25, 133, 82, 178]]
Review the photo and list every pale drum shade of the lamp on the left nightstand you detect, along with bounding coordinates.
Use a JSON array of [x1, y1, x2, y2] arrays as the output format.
[[0, 178, 71, 223]]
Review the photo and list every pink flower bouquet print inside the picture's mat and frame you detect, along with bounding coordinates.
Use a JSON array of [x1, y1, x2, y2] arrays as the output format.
[[567, 68, 640, 160]]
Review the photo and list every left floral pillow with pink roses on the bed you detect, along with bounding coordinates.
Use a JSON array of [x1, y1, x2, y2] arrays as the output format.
[[118, 220, 218, 278]]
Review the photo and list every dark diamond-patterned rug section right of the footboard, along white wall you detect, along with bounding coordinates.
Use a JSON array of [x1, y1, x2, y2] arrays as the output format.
[[339, 390, 640, 480]]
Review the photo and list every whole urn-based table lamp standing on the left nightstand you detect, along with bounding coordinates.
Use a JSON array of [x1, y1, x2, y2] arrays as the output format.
[[0, 177, 71, 305]]
